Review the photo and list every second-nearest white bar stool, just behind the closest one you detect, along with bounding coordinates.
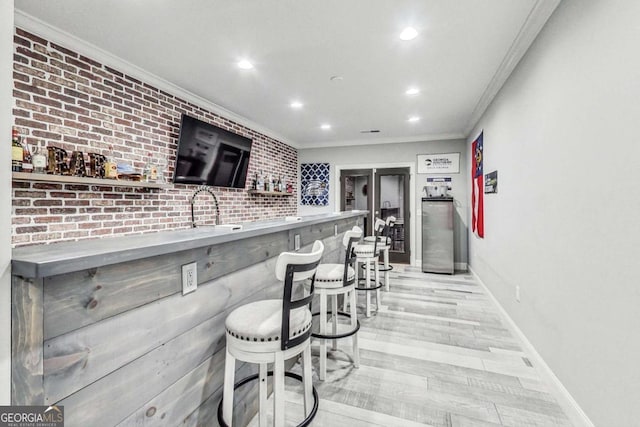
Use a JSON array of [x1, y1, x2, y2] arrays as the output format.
[[311, 226, 362, 381]]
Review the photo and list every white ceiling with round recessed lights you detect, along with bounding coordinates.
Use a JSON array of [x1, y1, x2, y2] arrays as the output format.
[[15, 0, 559, 148]]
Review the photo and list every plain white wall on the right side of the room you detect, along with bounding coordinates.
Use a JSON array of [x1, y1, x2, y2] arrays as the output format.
[[467, 0, 640, 427]]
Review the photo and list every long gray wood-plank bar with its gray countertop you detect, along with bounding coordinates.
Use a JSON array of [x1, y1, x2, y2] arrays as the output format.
[[11, 211, 366, 427]]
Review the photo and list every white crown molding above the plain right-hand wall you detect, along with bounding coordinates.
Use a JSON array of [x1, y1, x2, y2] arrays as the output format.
[[465, 0, 562, 136]]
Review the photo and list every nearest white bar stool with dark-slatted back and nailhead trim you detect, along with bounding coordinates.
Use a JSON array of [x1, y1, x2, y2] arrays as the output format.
[[218, 240, 324, 427]]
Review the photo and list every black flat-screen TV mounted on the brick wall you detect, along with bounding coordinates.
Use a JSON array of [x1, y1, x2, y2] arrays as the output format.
[[173, 114, 251, 188]]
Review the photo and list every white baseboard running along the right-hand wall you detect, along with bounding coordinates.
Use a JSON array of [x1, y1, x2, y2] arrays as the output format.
[[468, 265, 595, 427]]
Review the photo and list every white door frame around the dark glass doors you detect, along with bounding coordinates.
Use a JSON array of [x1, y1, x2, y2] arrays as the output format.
[[333, 162, 420, 266]]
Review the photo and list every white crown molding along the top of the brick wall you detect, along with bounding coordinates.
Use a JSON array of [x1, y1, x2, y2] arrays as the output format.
[[14, 9, 299, 148]]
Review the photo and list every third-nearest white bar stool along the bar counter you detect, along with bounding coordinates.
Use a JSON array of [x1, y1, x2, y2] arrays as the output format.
[[353, 219, 385, 317]]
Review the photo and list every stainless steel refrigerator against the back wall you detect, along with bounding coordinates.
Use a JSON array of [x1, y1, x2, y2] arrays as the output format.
[[422, 197, 454, 274]]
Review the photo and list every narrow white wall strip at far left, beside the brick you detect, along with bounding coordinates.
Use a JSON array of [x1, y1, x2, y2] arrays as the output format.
[[0, 0, 13, 405]]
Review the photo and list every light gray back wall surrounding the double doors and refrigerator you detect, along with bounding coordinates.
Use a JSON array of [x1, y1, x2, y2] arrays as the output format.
[[298, 140, 469, 268]]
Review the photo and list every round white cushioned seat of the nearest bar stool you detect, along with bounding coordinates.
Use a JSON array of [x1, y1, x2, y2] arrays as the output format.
[[225, 299, 312, 345]]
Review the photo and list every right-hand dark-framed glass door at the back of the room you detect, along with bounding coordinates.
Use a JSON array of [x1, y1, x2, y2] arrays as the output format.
[[374, 168, 411, 264]]
